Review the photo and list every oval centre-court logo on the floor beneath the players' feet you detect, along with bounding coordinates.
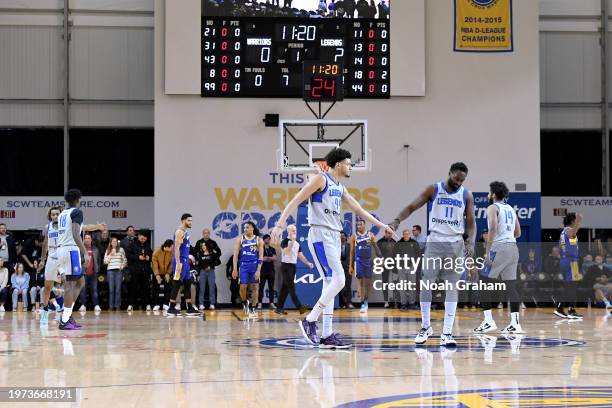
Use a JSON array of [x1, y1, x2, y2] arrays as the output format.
[[225, 335, 585, 352]]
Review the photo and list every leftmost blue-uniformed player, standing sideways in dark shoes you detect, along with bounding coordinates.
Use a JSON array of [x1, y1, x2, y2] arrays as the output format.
[[166, 214, 201, 318]]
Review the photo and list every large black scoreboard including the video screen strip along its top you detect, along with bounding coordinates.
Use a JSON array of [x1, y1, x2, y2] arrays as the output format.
[[201, 0, 391, 100]]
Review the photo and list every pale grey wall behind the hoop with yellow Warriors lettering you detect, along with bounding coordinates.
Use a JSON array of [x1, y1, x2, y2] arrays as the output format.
[[155, 0, 540, 278]]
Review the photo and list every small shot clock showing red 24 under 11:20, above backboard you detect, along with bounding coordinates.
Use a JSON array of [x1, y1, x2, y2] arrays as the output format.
[[302, 61, 344, 102]]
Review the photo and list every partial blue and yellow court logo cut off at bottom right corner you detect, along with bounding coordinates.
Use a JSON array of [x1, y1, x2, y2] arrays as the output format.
[[336, 387, 612, 408]]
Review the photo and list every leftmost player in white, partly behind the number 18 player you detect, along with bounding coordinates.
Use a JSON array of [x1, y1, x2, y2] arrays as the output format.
[[40, 206, 62, 326]]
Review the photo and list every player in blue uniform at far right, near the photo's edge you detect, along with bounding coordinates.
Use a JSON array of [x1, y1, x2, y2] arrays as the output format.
[[553, 213, 582, 319]]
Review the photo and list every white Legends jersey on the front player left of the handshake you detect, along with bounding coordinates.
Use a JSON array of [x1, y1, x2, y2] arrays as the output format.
[[308, 173, 346, 231]]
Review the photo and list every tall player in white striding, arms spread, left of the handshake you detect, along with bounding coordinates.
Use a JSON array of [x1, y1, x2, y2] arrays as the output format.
[[271, 149, 391, 349]]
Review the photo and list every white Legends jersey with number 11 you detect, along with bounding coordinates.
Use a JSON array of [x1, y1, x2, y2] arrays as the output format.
[[428, 181, 467, 242]]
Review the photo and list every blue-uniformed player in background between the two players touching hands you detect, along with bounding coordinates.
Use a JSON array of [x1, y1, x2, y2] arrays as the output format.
[[349, 220, 381, 313]]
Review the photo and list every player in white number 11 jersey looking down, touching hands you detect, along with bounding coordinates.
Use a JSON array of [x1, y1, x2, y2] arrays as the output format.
[[391, 163, 476, 347]]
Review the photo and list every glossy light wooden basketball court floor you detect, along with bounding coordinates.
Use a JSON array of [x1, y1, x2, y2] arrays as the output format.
[[0, 309, 612, 408]]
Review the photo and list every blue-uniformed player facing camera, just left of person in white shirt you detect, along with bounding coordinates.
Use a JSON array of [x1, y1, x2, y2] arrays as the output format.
[[232, 221, 264, 318]]
